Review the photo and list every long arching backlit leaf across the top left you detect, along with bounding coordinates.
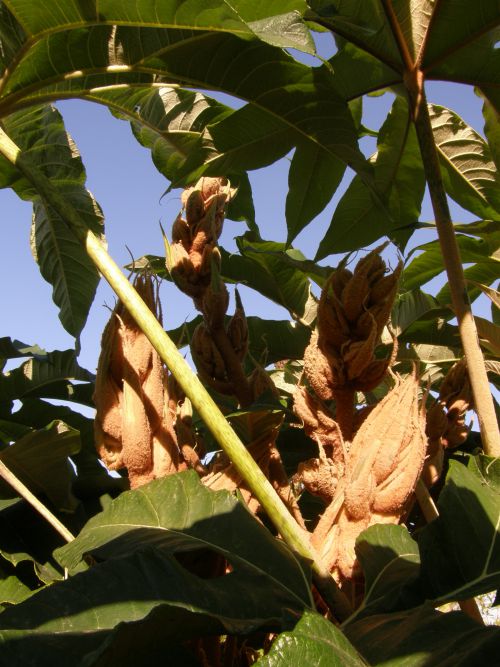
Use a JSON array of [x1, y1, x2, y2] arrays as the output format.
[[0, 2, 364, 176]]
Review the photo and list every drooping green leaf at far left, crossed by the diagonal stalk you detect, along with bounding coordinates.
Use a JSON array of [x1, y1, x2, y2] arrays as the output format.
[[0, 106, 103, 337]]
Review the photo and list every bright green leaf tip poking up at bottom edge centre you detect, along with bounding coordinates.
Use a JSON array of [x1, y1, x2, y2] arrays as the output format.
[[255, 611, 366, 667]]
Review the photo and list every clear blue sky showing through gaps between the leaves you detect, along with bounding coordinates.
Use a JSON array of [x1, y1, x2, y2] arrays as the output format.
[[0, 35, 489, 380]]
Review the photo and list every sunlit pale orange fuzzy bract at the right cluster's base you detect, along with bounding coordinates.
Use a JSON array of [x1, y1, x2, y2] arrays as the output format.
[[313, 375, 427, 581]]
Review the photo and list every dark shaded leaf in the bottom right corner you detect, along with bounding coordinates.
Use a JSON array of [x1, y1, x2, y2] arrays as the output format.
[[345, 605, 500, 667]]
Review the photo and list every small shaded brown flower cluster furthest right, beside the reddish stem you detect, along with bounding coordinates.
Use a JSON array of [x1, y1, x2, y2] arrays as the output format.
[[424, 359, 474, 486]]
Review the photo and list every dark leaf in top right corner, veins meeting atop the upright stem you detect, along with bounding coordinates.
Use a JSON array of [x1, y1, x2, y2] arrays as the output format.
[[307, 0, 500, 111]]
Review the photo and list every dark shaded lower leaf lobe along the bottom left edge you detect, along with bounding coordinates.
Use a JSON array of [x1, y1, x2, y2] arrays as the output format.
[[0, 544, 303, 666]]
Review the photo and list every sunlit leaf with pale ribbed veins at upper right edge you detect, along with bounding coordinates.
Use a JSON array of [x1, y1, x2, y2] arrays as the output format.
[[429, 104, 500, 219]]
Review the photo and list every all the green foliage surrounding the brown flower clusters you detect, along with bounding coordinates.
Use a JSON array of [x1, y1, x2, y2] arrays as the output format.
[[0, 0, 500, 667]]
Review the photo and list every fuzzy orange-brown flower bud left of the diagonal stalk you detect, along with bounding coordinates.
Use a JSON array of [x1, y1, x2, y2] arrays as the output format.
[[94, 276, 185, 488]]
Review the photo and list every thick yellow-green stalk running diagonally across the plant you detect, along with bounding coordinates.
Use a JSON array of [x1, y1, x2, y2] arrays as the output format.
[[0, 128, 351, 620]]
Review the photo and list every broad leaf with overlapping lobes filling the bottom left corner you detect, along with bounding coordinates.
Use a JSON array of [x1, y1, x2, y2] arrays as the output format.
[[0, 472, 312, 665]]
